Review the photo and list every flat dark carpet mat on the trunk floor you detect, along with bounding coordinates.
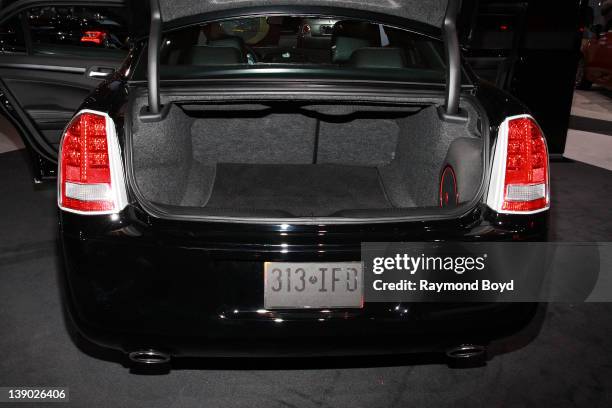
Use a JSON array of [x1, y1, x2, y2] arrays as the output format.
[[205, 163, 394, 217]]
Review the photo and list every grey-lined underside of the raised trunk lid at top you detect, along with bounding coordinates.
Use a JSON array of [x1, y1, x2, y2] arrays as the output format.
[[159, 0, 450, 27]]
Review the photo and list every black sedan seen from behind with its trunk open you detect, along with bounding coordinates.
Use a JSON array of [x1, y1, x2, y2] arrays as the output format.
[[1, 0, 550, 363]]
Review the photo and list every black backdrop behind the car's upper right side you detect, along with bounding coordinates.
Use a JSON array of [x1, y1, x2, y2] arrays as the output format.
[[459, 0, 590, 157]]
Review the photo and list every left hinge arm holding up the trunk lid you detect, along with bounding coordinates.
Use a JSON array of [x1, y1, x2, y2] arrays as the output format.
[[140, 0, 169, 122]]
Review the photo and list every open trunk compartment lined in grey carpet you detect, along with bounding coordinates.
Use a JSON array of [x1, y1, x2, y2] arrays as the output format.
[[126, 98, 484, 219]]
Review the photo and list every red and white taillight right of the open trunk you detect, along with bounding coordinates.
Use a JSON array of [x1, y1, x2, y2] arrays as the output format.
[[487, 115, 550, 214]]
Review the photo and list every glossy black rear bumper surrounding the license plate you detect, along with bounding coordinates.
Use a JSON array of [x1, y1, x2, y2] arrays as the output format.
[[61, 207, 548, 356]]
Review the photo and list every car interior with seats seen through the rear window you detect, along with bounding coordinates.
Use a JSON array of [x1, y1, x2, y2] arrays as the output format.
[[161, 17, 444, 70]]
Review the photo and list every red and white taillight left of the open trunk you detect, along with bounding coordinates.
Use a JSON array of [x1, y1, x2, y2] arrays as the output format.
[[58, 111, 127, 214]]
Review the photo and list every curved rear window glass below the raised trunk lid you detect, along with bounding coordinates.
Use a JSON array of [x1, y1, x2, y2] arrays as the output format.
[[136, 16, 446, 83]]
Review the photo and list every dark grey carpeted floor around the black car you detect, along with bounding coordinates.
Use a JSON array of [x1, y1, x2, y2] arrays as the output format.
[[0, 152, 612, 408]]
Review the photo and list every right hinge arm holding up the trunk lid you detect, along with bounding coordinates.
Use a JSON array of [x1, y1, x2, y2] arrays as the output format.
[[438, 0, 467, 122]]
